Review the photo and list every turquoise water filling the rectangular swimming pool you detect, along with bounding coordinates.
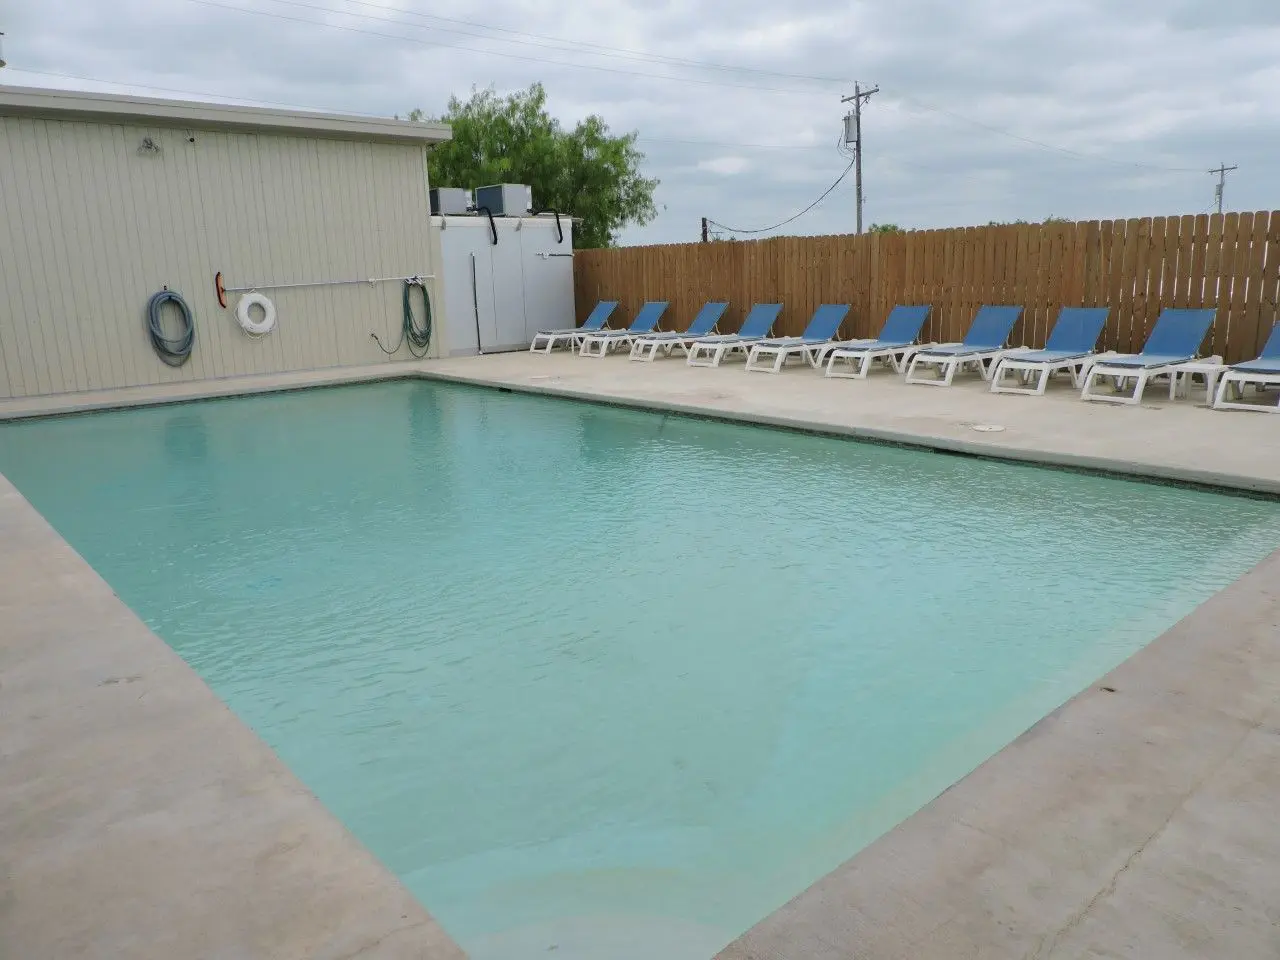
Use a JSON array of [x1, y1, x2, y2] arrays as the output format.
[[0, 383, 1280, 960]]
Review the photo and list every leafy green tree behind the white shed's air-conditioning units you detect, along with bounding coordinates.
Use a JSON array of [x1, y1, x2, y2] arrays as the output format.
[[408, 83, 658, 247]]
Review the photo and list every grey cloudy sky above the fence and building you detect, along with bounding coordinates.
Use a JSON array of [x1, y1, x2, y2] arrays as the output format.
[[0, 0, 1280, 243]]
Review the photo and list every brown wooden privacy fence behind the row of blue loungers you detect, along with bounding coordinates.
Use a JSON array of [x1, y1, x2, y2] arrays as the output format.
[[573, 211, 1280, 362]]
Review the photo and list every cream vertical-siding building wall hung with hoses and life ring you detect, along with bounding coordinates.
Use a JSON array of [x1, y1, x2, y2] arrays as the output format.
[[0, 118, 443, 398]]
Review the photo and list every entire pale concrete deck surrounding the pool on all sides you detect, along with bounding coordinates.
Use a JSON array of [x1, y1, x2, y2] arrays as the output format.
[[0, 353, 1280, 960]]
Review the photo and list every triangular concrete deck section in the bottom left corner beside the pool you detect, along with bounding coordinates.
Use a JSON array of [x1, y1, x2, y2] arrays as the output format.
[[0, 477, 465, 960]]
